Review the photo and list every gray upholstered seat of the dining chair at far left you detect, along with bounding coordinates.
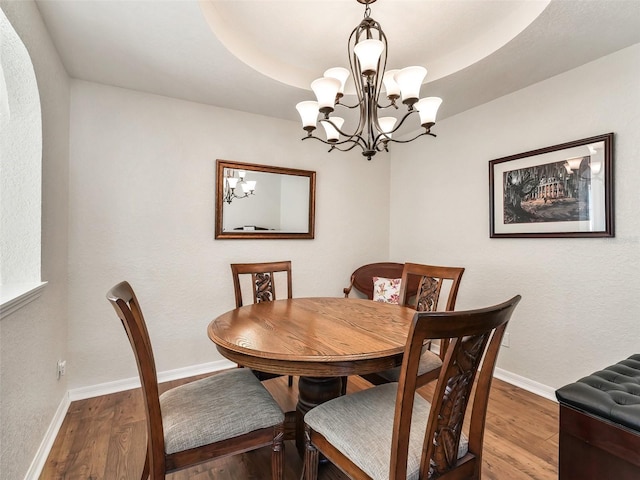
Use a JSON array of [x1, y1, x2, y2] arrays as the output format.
[[160, 368, 284, 454]]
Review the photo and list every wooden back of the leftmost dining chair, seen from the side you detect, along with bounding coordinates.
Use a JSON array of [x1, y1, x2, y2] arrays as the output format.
[[107, 282, 166, 479]]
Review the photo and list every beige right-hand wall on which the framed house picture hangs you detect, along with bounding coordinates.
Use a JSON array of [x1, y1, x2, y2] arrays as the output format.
[[390, 45, 640, 390]]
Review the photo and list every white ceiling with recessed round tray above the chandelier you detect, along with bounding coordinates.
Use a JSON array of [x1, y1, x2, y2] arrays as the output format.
[[36, 0, 640, 125]]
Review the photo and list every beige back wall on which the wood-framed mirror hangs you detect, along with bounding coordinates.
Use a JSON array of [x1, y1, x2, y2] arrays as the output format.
[[69, 81, 389, 388]]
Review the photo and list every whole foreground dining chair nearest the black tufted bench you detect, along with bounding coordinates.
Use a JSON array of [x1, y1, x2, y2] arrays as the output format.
[[304, 295, 520, 480]]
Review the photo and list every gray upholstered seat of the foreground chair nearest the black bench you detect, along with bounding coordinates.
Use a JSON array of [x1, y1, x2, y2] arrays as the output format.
[[304, 383, 469, 480]]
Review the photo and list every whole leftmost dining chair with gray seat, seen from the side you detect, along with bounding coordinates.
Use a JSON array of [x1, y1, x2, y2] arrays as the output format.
[[107, 282, 284, 480]]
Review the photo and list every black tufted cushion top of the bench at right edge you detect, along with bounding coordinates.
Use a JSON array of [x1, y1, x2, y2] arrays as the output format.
[[556, 354, 640, 431]]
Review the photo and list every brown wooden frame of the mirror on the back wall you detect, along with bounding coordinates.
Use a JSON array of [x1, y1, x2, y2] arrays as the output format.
[[215, 159, 316, 240]]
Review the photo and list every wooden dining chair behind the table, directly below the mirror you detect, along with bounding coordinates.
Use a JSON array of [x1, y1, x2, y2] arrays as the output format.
[[231, 260, 293, 387]]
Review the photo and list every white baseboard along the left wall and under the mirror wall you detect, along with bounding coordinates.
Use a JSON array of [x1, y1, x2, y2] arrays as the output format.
[[24, 360, 236, 480]]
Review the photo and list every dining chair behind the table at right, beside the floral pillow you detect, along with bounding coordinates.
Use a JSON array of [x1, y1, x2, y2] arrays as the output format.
[[362, 263, 464, 386]]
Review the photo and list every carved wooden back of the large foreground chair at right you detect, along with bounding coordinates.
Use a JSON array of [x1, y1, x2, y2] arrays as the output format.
[[389, 295, 520, 480]]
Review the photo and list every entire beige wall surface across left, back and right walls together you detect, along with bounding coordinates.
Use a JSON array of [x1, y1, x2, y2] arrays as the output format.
[[0, 0, 640, 479]]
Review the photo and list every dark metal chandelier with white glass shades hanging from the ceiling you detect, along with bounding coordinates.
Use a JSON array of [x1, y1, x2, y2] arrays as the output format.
[[296, 0, 442, 160]]
